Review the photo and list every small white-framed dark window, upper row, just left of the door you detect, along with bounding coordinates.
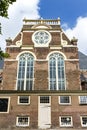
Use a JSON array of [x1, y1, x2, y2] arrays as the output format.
[[18, 96, 30, 105]]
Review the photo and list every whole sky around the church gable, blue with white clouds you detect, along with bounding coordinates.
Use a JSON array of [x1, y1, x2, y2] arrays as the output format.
[[0, 0, 87, 55]]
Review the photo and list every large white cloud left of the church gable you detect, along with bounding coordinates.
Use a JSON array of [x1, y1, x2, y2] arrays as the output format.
[[0, 0, 40, 50]]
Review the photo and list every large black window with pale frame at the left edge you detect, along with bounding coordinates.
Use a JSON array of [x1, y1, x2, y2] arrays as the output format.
[[0, 97, 10, 113]]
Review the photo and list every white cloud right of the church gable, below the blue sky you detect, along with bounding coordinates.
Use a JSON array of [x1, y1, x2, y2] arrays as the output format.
[[65, 17, 87, 55]]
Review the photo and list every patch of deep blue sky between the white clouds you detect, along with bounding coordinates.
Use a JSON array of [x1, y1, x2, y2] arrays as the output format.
[[39, 0, 87, 27]]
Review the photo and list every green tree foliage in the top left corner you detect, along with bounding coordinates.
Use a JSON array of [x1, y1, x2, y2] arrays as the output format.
[[0, 0, 16, 17]]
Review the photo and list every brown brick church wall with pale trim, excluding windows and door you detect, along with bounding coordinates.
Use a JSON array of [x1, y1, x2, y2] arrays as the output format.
[[0, 20, 87, 130]]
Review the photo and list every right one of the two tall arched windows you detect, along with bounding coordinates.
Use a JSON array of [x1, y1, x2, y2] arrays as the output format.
[[49, 53, 65, 90]]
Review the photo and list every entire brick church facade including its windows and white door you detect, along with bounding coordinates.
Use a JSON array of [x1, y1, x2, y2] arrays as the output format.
[[0, 19, 87, 130]]
